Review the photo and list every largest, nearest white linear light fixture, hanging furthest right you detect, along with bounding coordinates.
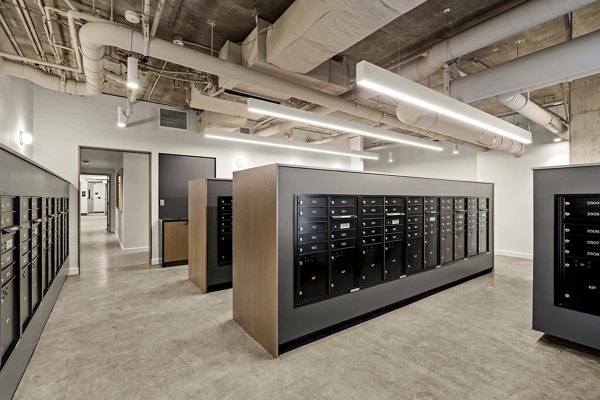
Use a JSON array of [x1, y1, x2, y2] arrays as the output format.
[[356, 61, 531, 144]]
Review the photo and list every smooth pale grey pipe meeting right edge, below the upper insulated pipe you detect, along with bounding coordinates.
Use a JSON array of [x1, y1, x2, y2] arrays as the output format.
[[450, 30, 600, 103]]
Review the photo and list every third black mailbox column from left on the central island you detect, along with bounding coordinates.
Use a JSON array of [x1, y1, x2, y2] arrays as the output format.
[[358, 196, 385, 287]]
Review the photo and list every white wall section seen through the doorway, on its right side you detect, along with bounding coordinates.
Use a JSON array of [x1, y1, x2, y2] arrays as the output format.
[[122, 153, 150, 250]]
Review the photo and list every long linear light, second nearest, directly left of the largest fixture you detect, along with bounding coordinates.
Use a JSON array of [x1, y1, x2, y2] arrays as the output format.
[[248, 98, 444, 151]]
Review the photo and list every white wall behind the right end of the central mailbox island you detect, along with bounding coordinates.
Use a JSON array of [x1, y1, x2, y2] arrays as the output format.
[[365, 142, 569, 258]]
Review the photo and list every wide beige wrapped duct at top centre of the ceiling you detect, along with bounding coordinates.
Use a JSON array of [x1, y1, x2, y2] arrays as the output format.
[[267, 0, 425, 74]]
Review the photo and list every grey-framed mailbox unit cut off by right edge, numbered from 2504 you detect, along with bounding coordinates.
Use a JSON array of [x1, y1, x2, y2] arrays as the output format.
[[536, 165, 600, 349]]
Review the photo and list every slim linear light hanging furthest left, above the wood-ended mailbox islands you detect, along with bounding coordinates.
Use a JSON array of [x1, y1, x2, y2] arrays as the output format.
[[204, 129, 379, 160]]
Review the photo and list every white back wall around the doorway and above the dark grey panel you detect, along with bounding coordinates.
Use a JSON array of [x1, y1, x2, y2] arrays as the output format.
[[33, 86, 350, 269]]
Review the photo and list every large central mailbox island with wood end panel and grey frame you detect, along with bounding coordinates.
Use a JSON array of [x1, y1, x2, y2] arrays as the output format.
[[233, 165, 493, 356]]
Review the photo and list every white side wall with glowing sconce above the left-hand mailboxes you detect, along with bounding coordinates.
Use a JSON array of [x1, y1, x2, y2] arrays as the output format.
[[0, 63, 35, 158]]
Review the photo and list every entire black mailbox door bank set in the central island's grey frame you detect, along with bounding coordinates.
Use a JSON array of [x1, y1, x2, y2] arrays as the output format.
[[294, 194, 489, 307]]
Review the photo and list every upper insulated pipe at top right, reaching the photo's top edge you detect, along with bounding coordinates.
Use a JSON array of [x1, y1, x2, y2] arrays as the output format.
[[398, 0, 596, 81]]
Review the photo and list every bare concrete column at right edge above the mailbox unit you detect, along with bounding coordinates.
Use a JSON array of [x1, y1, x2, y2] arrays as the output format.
[[570, 74, 600, 164]]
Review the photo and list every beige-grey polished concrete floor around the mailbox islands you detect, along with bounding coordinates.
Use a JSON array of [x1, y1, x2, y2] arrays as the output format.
[[16, 217, 600, 400]]
